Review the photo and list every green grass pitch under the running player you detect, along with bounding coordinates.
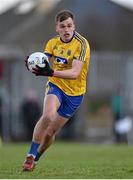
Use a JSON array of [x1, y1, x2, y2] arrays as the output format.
[[0, 142, 133, 179]]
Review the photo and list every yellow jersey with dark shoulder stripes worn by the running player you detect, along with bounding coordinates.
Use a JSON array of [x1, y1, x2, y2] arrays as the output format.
[[44, 32, 90, 96]]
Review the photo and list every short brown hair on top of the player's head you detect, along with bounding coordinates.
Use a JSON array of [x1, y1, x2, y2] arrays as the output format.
[[55, 10, 75, 22]]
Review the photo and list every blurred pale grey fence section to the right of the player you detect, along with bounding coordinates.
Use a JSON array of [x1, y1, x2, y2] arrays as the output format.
[[89, 52, 133, 114]]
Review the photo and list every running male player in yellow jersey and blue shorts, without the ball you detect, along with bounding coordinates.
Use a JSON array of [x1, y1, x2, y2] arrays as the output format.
[[23, 10, 90, 171]]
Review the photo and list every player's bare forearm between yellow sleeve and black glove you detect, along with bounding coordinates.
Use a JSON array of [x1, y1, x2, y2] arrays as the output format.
[[53, 60, 83, 79]]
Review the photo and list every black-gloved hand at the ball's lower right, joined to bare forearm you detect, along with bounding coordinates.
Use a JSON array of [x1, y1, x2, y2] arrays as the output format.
[[32, 60, 54, 76]]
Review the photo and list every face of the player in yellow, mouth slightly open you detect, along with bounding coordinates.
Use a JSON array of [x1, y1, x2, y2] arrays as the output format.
[[56, 18, 75, 42]]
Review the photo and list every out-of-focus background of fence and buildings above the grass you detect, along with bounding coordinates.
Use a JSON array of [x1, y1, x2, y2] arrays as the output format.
[[0, 0, 133, 144]]
